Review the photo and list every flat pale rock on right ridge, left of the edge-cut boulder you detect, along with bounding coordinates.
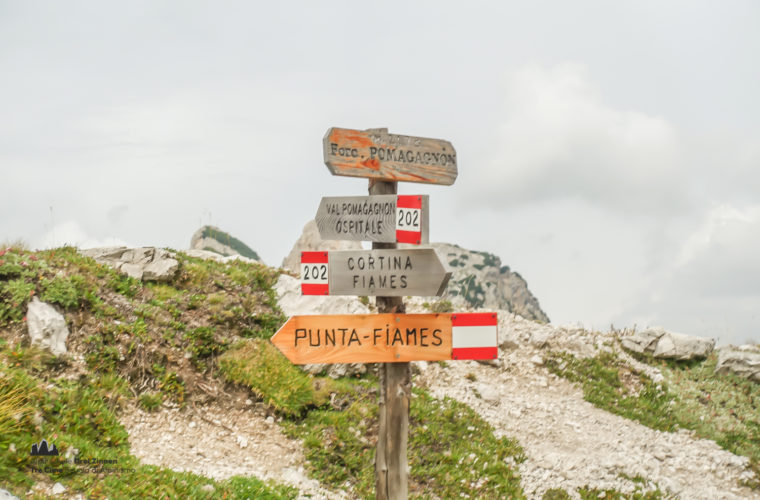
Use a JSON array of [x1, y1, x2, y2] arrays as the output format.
[[621, 327, 715, 361]]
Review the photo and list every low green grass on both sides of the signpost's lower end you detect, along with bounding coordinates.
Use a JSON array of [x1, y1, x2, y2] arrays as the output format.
[[286, 380, 525, 498]]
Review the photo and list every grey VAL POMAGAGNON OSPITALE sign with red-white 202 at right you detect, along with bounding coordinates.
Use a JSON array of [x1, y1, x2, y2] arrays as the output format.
[[314, 194, 429, 245]]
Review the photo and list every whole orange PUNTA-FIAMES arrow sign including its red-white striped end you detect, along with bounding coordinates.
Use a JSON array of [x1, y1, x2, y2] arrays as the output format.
[[272, 313, 499, 365]]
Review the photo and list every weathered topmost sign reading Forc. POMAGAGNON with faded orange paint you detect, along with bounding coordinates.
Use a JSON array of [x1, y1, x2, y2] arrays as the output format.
[[322, 127, 457, 186]]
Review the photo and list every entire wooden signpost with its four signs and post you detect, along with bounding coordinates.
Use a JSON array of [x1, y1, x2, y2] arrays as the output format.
[[272, 128, 492, 500]]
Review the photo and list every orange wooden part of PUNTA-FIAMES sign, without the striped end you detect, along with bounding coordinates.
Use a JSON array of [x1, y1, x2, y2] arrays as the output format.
[[272, 313, 452, 365]]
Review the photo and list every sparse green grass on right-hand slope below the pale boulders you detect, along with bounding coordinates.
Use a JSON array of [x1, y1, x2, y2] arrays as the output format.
[[546, 353, 760, 488]]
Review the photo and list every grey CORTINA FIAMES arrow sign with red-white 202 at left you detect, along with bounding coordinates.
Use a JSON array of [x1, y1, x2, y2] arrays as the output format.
[[301, 248, 451, 297]]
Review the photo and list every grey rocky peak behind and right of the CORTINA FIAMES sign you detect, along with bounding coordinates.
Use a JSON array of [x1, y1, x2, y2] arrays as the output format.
[[431, 243, 549, 323]]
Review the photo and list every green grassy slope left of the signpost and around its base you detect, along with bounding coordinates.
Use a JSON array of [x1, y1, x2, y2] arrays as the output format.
[[0, 248, 522, 499]]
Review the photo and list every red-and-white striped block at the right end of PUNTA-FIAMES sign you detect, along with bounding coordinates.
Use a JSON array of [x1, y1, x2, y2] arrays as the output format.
[[451, 313, 499, 359]]
